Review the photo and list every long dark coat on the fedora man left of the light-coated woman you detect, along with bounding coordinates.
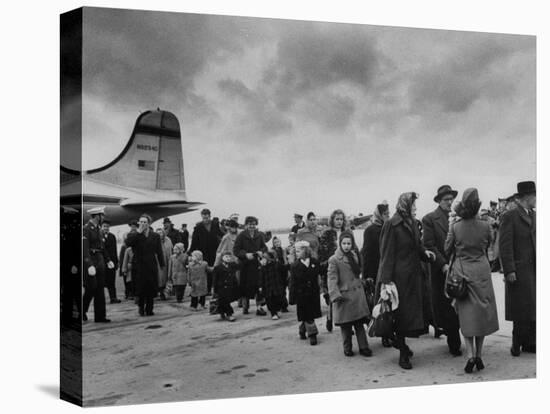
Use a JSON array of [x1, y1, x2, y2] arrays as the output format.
[[422, 207, 458, 330]]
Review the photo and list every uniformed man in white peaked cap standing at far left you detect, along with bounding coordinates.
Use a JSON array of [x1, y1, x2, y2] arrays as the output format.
[[82, 207, 115, 322]]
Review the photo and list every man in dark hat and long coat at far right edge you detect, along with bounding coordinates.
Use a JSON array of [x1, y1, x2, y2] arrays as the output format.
[[499, 181, 537, 356]]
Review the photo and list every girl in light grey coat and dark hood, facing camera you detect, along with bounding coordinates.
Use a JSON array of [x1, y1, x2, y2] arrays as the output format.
[[328, 231, 372, 357]]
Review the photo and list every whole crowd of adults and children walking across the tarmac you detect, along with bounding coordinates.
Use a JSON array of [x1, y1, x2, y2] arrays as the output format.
[[64, 181, 536, 373]]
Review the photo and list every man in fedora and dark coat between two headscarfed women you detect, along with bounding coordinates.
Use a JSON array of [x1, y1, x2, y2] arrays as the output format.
[[422, 185, 462, 356]]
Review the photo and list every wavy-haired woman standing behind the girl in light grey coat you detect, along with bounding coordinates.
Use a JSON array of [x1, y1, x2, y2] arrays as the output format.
[[319, 209, 348, 332]]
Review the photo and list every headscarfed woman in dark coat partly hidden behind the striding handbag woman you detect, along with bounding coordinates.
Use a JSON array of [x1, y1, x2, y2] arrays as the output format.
[[361, 201, 392, 348]]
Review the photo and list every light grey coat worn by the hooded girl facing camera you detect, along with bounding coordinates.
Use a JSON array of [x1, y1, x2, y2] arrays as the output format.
[[328, 249, 370, 325]]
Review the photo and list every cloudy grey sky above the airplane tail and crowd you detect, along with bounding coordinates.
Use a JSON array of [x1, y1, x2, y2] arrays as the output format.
[[71, 9, 536, 228]]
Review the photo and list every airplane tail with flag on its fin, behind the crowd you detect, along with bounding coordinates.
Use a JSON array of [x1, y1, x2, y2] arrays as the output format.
[[61, 109, 203, 226]]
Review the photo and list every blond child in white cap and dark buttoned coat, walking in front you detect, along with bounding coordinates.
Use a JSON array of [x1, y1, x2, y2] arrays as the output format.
[[289, 241, 321, 345]]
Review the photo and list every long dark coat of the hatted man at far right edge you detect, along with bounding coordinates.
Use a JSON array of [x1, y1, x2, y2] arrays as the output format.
[[499, 206, 537, 321]]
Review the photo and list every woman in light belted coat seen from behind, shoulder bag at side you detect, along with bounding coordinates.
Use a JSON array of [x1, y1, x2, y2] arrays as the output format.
[[445, 188, 498, 373]]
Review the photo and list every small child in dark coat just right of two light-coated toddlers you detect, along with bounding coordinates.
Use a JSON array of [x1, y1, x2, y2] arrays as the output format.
[[212, 251, 239, 322]]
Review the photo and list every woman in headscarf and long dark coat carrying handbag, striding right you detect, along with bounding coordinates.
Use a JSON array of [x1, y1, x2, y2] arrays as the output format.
[[377, 192, 435, 369]]
